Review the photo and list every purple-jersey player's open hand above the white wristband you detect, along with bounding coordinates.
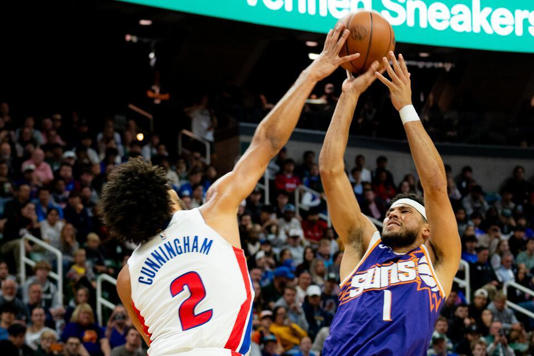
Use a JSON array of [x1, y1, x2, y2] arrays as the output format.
[[375, 52, 412, 110]]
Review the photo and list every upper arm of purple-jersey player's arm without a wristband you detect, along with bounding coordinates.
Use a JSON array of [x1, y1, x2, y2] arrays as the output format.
[[321, 172, 376, 250]]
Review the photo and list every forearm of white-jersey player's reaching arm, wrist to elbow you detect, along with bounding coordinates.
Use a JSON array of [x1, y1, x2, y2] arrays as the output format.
[[253, 69, 317, 157]]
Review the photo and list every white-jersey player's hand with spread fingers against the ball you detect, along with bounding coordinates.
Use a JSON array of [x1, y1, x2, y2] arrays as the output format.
[[309, 23, 360, 81]]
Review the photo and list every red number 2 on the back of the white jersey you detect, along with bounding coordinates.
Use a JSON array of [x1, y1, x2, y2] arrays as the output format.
[[171, 272, 213, 331]]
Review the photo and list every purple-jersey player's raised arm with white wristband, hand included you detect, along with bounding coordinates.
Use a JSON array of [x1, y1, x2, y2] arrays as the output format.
[[376, 52, 461, 293]]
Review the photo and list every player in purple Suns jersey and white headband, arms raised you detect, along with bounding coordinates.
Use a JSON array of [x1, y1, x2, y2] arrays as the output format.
[[319, 52, 461, 356]]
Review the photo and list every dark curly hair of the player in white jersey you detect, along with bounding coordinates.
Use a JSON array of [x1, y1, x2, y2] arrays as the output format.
[[100, 158, 172, 244]]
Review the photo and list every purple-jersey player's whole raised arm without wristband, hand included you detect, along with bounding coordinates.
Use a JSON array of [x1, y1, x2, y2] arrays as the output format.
[[319, 62, 378, 268]]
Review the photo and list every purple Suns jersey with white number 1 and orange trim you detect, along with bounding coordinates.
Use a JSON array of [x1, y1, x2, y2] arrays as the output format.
[[323, 232, 445, 356]]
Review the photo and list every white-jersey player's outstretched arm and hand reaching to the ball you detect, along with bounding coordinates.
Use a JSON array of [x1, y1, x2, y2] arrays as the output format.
[[202, 24, 358, 245]]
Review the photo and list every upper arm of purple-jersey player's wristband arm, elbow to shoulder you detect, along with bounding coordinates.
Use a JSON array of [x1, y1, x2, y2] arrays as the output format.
[[425, 192, 462, 288]]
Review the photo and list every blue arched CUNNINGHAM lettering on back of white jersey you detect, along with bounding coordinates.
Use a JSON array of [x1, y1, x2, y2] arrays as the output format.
[[137, 236, 213, 285]]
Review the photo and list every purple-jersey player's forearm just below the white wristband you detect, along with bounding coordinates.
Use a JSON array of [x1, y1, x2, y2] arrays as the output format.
[[404, 108, 447, 194]]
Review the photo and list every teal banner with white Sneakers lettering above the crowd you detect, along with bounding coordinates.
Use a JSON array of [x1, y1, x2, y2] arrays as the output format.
[[119, 0, 534, 53]]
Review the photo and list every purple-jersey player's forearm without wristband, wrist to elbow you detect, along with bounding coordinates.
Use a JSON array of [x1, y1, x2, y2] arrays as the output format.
[[319, 93, 358, 175]]
